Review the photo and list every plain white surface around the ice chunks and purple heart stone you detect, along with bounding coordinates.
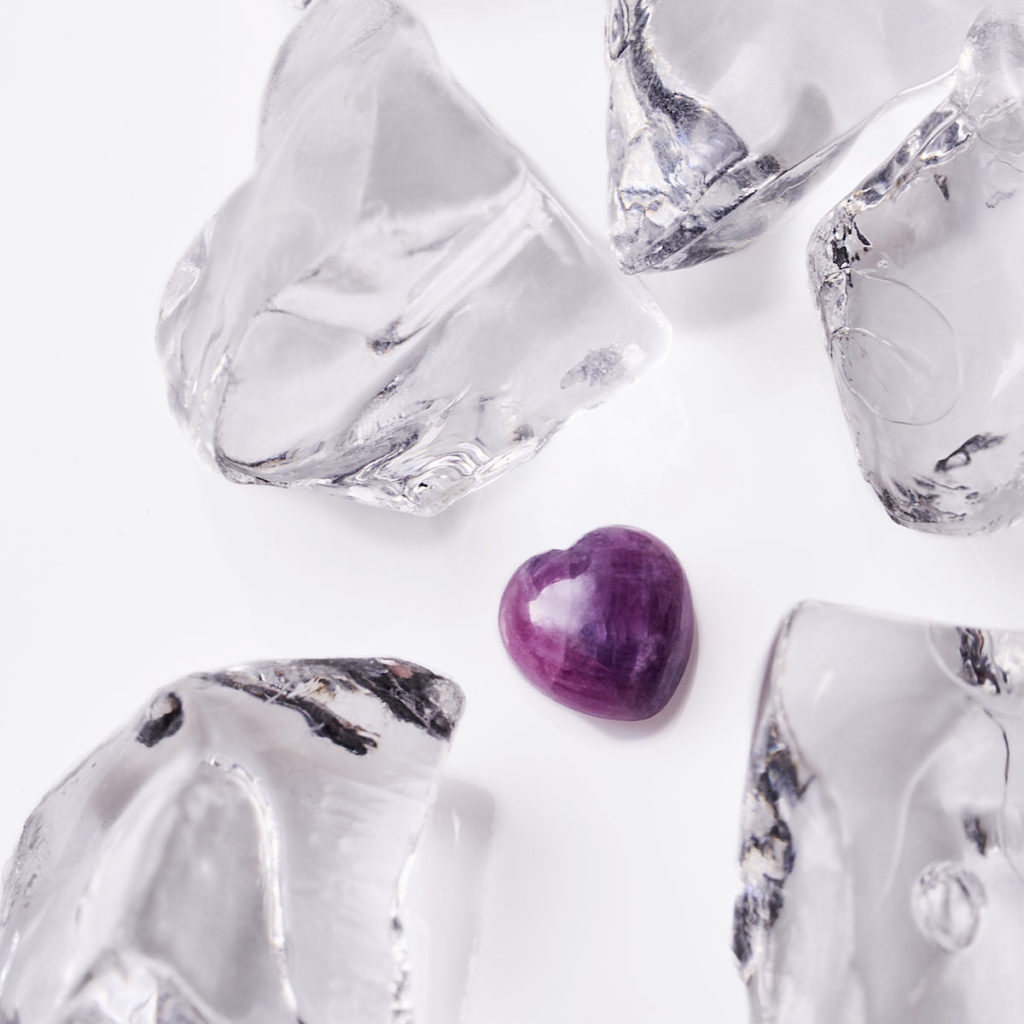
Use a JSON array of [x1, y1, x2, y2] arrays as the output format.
[[6, 0, 1024, 1024]]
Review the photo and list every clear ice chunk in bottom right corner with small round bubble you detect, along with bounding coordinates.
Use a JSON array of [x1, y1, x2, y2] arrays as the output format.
[[733, 604, 1024, 1024]]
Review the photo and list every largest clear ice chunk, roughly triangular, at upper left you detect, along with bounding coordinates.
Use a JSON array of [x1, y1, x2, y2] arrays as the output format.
[[159, 0, 670, 514]]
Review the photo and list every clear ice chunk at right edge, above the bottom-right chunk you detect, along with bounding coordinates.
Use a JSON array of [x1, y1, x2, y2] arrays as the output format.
[[809, 8, 1024, 534]]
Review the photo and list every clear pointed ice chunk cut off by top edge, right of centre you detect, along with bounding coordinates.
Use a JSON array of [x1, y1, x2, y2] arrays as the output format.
[[607, 0, 982, 273]]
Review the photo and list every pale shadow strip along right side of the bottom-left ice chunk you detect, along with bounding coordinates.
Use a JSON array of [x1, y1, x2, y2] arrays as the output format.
[[401, 778, 495, 1024]]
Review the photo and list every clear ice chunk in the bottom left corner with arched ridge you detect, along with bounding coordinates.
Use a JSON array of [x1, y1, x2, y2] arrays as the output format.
[[0, 660, 462, 1024]]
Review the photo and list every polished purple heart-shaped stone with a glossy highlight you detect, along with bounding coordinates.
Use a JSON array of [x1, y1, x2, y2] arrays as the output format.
[[499, 526, 693, 721]]
